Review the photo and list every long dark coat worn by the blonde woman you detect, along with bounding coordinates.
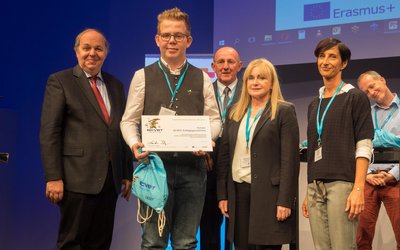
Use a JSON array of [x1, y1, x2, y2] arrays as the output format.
[[217, 102, 300, 245]]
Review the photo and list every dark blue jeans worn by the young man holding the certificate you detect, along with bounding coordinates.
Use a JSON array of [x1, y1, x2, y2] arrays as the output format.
[[141, 156, 207, 250]]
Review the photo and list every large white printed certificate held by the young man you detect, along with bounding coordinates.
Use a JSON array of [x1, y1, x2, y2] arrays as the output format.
[[142, 115, 212, 152]]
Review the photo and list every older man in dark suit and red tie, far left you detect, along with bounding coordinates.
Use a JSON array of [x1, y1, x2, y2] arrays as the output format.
[[40, 29, 133, 249]]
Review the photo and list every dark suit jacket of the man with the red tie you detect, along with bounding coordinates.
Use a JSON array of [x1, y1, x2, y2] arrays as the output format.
[[40, 65, 133, 194]]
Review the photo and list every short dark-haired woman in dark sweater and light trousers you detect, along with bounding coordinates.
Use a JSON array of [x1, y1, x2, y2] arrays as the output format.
[[302, 38, 374, 250]]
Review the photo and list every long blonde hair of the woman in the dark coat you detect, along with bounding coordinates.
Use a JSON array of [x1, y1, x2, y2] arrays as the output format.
[[229, 58, 285, 122]]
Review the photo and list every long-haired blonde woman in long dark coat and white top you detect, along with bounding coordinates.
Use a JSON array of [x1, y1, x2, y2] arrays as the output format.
[[217, 58, 300, 250]]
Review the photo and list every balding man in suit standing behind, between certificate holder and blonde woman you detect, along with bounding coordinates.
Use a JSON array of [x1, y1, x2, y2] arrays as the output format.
[[200, 47, 243, 250]]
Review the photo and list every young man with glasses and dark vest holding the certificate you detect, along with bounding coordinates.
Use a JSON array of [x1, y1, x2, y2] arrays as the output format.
[[121, 8, 221, 249]]
